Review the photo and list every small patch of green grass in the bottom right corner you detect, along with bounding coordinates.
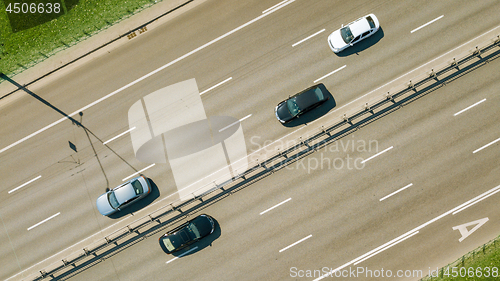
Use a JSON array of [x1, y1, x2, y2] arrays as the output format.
[[422, 237, 500, 281]]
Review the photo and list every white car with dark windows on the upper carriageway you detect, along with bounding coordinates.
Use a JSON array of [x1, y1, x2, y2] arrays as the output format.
[[328, 14, 380, 53]]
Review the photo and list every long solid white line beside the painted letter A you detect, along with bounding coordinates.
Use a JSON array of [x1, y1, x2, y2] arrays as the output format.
[[313, 183, 500, 281]]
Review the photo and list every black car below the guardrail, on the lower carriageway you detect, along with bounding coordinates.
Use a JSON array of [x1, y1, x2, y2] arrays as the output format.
[[158, 214, 215, 254]]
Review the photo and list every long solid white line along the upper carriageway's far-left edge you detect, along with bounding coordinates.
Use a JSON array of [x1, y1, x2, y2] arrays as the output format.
[[0, 0, 295, 153]]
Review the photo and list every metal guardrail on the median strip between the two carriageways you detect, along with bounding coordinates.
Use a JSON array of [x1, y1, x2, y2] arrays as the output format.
[[25, 32, 500, 280]]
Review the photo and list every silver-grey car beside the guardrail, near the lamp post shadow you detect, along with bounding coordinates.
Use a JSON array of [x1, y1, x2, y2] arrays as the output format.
[[96, 176, 151, 216]]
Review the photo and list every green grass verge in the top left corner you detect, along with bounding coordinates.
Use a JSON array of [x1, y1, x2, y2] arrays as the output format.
[[0, 0, 154, 75]]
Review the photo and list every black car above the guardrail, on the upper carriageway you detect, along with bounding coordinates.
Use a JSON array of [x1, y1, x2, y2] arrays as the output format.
[[274, 83, 331, 123]]
